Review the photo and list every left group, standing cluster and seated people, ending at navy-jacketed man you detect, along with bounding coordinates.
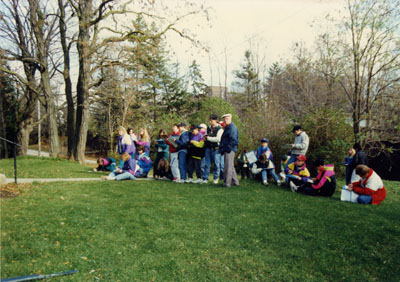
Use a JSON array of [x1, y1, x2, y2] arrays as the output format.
[[95, 114, 239, 187]]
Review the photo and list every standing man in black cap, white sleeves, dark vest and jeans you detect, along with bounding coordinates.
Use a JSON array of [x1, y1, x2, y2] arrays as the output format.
[[202, 114, 224, 184]]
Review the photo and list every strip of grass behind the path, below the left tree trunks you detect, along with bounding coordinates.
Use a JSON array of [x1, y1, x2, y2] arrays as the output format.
[[0, 156, 106, 178]]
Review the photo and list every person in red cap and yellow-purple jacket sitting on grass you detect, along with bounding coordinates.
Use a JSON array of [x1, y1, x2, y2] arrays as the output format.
[[285, 155, 311, 191]]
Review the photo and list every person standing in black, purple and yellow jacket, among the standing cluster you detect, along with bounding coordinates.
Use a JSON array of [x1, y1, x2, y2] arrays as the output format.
[[186, 125, 204, 183]]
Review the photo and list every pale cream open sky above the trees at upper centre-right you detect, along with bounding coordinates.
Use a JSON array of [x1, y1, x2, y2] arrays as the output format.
[[166, 0, 345, 87]]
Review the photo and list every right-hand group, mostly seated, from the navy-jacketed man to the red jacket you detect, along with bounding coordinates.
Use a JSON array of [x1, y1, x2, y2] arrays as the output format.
[[238, 125, 386, 204]]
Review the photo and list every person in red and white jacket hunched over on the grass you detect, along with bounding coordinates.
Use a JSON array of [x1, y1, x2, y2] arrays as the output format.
[[347, 165, 386, 205]]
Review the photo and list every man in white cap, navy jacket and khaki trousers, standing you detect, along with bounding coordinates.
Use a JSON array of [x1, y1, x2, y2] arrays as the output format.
[[219, 114, 239, 187]]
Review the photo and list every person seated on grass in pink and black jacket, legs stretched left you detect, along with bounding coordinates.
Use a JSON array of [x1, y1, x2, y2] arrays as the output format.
[[292, 160, 336, 197]]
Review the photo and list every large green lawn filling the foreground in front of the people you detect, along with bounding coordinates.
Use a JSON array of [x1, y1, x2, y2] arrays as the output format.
[[1, 177, 400, 281]]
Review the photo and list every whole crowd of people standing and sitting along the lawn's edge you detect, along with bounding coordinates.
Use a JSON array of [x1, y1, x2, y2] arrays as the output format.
[[95, 117, 386, 204]]
